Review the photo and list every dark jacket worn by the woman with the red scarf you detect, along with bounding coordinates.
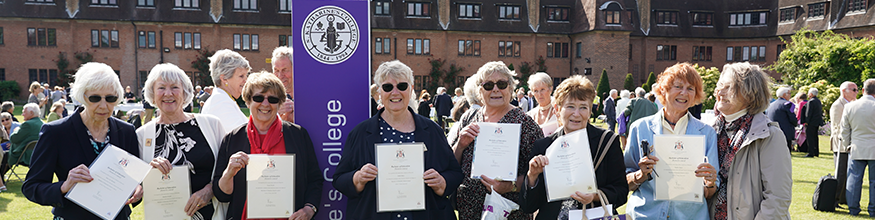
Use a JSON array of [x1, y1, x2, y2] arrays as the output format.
[[213, 121, 324, 219]]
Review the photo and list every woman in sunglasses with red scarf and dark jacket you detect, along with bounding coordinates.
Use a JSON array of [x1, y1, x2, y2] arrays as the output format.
[[213, 71, 323, 219]]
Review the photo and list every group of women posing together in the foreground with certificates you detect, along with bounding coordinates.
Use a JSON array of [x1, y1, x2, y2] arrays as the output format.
[[23, 50, 791, 219]]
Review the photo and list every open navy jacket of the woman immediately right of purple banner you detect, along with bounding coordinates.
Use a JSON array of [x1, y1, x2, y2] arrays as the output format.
[[333, 108, 463, 220]]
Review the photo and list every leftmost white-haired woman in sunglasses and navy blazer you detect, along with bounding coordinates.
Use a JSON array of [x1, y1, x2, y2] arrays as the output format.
[[21, 62, 142, 220]]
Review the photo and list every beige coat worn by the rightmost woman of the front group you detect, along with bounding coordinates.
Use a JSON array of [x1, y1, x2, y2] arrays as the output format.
[[708, 114, 793, 220]]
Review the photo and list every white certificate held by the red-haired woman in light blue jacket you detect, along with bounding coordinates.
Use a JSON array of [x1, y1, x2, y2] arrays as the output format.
[[651, 135, 705, 203]]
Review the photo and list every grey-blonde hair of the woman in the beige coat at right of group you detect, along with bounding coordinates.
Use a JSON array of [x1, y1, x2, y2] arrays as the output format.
[[718, 62, 771, 114]]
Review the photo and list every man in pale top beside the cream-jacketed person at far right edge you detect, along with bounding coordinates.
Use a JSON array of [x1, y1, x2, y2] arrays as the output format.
[[836, 81, 859, 207]]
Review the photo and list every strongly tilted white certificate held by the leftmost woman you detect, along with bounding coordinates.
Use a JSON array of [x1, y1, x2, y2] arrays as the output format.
[[66, 145, 152, 219]]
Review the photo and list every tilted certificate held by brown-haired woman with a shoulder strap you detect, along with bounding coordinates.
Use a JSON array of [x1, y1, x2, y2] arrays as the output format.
[[544, 129, 598, 202]]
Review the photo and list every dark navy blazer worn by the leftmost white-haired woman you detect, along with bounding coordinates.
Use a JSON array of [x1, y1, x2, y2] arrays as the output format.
[[21, 108, 140, 219]]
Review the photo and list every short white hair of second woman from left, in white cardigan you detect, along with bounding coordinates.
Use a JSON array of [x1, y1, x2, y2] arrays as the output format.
[[143, 63, 194, 106]]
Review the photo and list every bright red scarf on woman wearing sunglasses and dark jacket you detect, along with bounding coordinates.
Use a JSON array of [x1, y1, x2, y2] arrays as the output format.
[[240, 116, 286, 220]]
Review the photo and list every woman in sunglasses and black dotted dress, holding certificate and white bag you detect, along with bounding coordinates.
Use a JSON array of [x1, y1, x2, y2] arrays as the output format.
[[448, 61, 544, 219]]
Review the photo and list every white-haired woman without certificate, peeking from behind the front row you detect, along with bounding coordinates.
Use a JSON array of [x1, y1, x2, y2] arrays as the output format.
[[526, 72, 559, 136]]
